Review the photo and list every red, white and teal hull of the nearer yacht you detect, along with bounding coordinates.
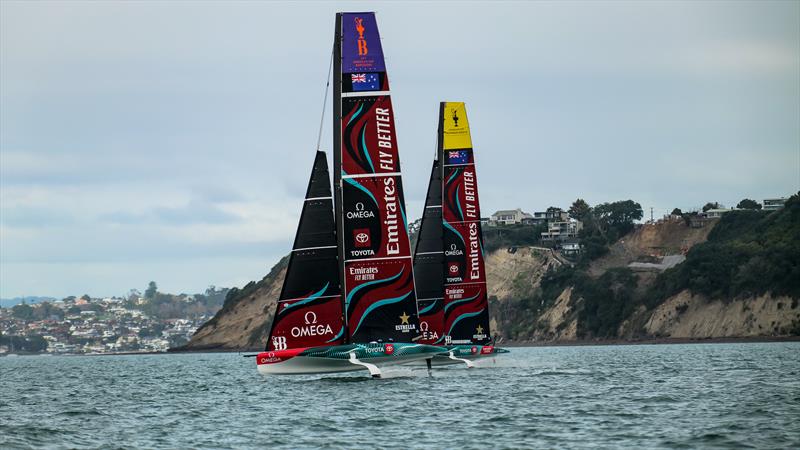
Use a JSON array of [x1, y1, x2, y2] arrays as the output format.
[[256, 343, 447, 376]]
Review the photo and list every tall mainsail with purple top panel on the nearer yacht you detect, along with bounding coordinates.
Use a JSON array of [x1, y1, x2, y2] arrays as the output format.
[[333, 12, 419, 342]]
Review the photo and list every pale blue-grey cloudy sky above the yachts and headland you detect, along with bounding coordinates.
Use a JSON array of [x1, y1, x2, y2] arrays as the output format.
[[0, 0, 800, 298]]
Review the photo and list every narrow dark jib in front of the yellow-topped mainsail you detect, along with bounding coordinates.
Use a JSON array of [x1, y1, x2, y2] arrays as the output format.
[[414, 161, 445, 344]]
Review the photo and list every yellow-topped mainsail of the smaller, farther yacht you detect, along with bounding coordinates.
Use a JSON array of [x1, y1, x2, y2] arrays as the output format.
[[439, 102, 490, 344]]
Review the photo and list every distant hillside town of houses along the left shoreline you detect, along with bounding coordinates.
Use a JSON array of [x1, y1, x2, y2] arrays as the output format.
[[0, 282, 228, 355]]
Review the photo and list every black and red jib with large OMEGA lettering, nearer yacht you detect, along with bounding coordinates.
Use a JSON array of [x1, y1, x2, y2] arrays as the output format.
[[267, 151, 344, 351]]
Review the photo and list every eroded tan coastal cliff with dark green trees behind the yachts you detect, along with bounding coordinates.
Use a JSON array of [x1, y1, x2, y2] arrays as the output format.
[[182, 196, 800, 350]]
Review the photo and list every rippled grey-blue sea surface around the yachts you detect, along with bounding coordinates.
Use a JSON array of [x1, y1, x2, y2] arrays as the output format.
[[0, 342, 800, 449]]
